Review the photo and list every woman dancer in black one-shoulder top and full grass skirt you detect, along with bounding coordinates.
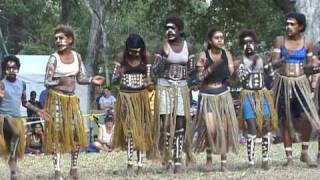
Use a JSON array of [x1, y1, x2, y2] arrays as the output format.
[[194, 28, 239, 171]]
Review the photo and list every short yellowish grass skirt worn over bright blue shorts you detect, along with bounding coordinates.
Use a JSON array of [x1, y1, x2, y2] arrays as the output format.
[[239, 88, 278, 133]]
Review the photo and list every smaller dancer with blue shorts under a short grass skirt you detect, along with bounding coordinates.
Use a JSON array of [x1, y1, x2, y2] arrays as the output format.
[[238, 29, 278, 170]]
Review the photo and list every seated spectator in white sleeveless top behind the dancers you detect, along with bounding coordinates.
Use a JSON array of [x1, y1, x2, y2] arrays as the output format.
[[94, 113, 114, 152]]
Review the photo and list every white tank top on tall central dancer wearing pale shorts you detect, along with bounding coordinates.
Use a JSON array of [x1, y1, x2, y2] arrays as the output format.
[[167, 41, 189, 64]]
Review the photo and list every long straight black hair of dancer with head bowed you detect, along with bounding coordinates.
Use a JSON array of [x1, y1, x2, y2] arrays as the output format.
[[124, 34, 147, 63]]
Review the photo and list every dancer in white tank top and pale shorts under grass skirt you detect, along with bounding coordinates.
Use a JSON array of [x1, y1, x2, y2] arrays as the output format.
[[153, 17, 195, 173]]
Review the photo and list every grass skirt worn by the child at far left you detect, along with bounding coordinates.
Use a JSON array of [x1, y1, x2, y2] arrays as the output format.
[[0, 116, 25, 159]]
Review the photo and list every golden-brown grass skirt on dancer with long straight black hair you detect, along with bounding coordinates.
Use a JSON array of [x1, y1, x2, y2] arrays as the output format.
[[112, 90, 153, 150]]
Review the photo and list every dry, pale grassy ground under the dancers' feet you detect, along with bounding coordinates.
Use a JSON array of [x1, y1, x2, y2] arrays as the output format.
[[0, 143, 320, 180]]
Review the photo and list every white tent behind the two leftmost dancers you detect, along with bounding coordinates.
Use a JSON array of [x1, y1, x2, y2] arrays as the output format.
[[17, 55, 89, 119]]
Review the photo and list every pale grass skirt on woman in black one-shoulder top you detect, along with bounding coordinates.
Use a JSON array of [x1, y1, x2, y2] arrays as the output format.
[[194, 90, 240, 154]]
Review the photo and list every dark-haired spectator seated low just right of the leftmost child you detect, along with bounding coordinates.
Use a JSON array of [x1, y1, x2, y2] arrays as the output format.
[[26, 123, 43, 155]]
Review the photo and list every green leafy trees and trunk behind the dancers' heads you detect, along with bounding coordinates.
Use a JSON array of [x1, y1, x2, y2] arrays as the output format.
[[0, 0, 290, 102]]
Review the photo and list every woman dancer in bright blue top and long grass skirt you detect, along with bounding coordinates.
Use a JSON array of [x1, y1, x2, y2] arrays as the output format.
[[272, 13, 320, 167]]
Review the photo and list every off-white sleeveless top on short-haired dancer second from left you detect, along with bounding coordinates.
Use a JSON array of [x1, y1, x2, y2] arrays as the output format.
[[53, 51, 79, 77]]
